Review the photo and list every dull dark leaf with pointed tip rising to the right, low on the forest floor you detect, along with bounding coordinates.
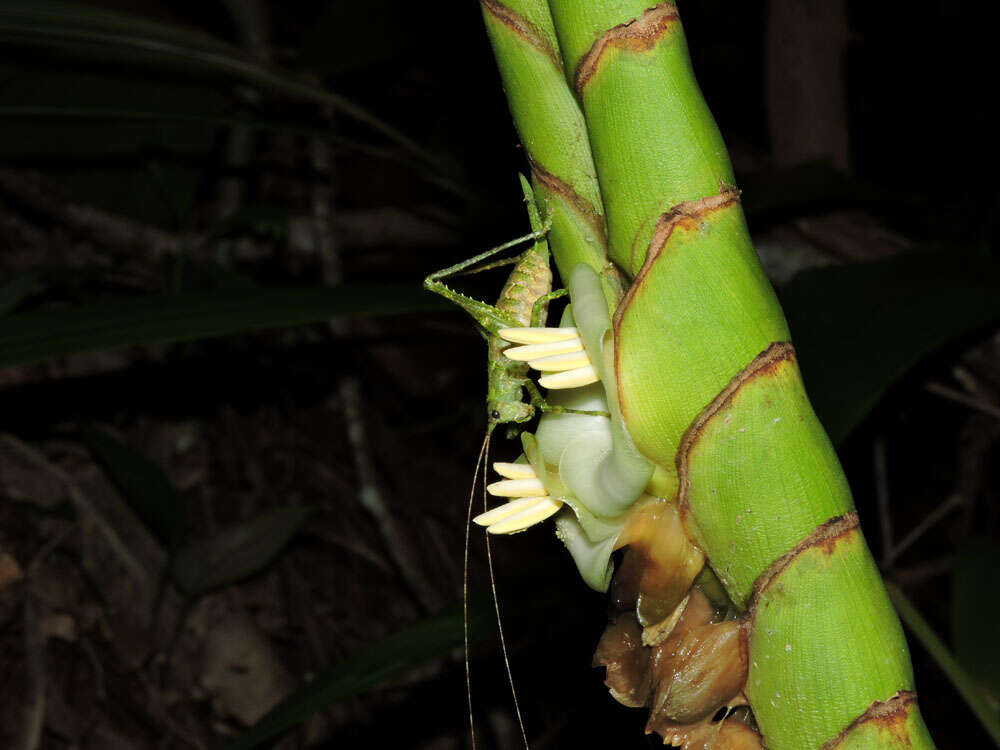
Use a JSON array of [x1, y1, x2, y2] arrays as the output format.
[[170, 508, 312, 597]]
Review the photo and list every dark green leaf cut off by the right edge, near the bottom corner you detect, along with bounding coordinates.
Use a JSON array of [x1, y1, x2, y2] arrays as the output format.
[[951, 539, 1000, 704]]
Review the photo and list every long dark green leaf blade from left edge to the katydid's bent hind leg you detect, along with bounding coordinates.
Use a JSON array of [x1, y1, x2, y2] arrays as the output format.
[[0, 283, 444, 366]]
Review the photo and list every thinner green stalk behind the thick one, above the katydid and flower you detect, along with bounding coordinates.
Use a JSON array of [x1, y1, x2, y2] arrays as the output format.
[[480, 0, 624, 309]]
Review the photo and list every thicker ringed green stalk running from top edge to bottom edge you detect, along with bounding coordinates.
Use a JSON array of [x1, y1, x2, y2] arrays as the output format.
[[550, 0, 933, 750]]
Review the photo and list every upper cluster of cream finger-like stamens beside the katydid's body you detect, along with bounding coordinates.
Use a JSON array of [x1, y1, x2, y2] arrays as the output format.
[[498, 328, 600, 390]]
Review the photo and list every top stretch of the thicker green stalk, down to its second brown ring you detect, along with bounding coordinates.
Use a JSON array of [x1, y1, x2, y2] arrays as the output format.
[[550, 0, 734, 275]]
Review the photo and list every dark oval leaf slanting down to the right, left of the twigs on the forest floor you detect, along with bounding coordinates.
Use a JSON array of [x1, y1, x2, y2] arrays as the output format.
[[83, 428, 184, 549]]
